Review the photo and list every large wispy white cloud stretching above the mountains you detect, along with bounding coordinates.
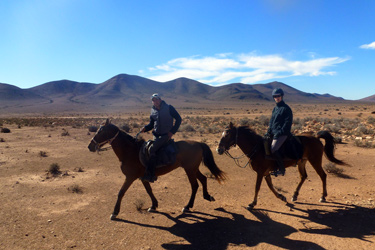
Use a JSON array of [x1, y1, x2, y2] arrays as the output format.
[[145, 53, 349, 85]]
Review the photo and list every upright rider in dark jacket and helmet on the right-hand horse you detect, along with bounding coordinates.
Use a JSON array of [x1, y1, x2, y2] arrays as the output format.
[[266, 88, 293, 176]]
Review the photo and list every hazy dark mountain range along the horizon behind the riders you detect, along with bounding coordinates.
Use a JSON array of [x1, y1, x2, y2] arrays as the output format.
[[0, 74, 375, 113]]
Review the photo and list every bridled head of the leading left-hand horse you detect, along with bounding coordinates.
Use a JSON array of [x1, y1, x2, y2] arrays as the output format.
[[89, 119, 120, 152]]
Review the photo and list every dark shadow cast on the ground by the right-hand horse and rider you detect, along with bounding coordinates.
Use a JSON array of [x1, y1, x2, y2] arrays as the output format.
[[262, 202, 375, 242]]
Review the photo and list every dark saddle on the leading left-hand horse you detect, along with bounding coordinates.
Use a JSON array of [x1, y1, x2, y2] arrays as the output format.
[[139, 139, 177, 168]]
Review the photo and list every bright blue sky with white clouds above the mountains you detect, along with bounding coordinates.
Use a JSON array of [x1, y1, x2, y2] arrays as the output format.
[[0, 0, 375, 100]]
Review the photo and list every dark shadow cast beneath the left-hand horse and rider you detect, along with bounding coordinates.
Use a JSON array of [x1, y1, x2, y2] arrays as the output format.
[[116, 208, 324, 250]]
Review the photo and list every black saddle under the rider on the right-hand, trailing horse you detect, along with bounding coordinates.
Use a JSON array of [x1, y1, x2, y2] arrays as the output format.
[[263, 135, 303, 160]]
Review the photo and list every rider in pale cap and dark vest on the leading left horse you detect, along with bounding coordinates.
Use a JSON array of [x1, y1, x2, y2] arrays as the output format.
[[141, 94, 182, 182]]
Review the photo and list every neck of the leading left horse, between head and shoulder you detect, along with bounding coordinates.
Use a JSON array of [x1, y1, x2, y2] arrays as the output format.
[[112, 132, 140, 162]]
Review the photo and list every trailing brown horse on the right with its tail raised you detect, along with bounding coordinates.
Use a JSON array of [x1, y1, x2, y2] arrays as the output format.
[[217, 123, 347, 210]]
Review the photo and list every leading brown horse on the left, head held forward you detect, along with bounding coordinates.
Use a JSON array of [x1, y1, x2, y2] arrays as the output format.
[[88, 119, 225, 220]]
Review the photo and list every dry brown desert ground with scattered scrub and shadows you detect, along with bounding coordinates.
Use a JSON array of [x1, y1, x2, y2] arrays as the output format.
[[0, 104, 375, 250]]
